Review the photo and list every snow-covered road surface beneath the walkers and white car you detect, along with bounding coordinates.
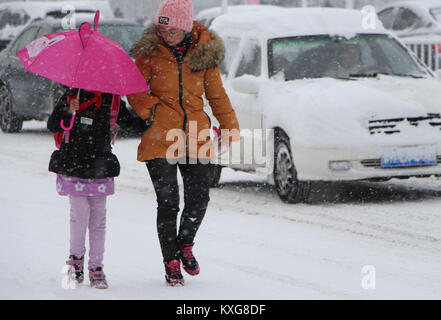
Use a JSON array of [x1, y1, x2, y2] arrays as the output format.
[[0, 122, 441, 300]]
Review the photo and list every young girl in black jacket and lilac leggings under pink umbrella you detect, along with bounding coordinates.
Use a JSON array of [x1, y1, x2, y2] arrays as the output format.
[[47, 89, 137, 289]]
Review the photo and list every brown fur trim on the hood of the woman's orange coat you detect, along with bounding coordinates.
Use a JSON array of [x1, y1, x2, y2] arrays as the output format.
[[132, 21, 225, 72]]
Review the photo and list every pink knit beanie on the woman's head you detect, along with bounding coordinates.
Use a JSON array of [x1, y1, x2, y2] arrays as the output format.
[[155, 0, 193, 32]]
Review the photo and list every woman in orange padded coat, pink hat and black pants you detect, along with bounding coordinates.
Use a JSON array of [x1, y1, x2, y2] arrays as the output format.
[[128, 0, 239, 286]]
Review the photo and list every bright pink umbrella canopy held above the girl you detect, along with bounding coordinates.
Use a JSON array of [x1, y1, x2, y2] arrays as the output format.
[[16, 11, 150, 96]]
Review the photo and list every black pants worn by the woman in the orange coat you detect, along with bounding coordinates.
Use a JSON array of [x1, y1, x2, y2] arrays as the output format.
[[146, 159, 210, 262]]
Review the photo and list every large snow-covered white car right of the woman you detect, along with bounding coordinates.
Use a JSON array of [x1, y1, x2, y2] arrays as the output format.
[[207, 8, 441, 203]]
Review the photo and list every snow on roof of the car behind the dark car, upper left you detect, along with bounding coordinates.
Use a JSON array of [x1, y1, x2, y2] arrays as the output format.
[[0, 1, 114, 19]]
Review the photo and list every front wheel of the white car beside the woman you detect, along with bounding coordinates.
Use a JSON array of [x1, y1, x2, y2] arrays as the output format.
[[273, 132, 311, 203]]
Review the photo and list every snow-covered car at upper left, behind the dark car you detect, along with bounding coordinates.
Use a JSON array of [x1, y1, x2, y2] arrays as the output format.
[[0, 1, 115, 51]]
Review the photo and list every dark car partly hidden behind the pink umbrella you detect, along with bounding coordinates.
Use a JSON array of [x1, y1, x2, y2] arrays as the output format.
[[0, 19, 144, 133]]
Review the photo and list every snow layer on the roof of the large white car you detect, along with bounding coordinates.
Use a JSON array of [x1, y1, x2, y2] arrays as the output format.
[[212, 8, 388, 38]]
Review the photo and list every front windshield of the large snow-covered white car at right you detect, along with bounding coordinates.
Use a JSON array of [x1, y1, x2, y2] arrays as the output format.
[[269, 34, 426, 81]]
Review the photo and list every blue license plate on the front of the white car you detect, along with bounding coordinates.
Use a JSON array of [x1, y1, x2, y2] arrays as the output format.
[[381, 146, 437, 168]]
